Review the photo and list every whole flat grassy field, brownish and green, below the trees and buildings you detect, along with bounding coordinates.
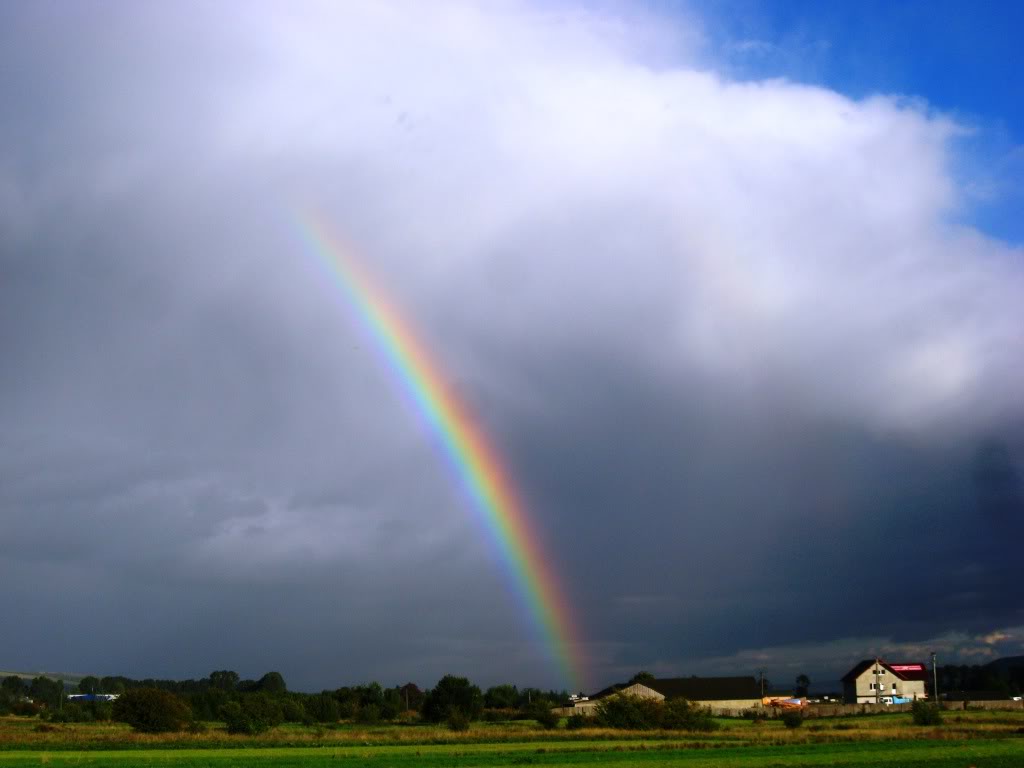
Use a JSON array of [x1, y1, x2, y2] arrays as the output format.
[[0, 712, 1024, 768]]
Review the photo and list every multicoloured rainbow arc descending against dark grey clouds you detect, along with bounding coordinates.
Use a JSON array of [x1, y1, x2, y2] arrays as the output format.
[[297, 211, 583, 690]]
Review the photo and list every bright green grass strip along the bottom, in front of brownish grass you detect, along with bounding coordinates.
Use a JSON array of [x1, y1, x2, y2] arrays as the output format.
[[0, 739, 1024, 768]]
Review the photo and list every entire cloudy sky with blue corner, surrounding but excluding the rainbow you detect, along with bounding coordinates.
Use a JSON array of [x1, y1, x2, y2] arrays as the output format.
[[0, 0, 1024, 690]]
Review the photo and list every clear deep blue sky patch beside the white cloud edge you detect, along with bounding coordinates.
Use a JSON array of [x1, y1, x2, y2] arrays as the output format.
[[688, 0, 1024, 243]]
